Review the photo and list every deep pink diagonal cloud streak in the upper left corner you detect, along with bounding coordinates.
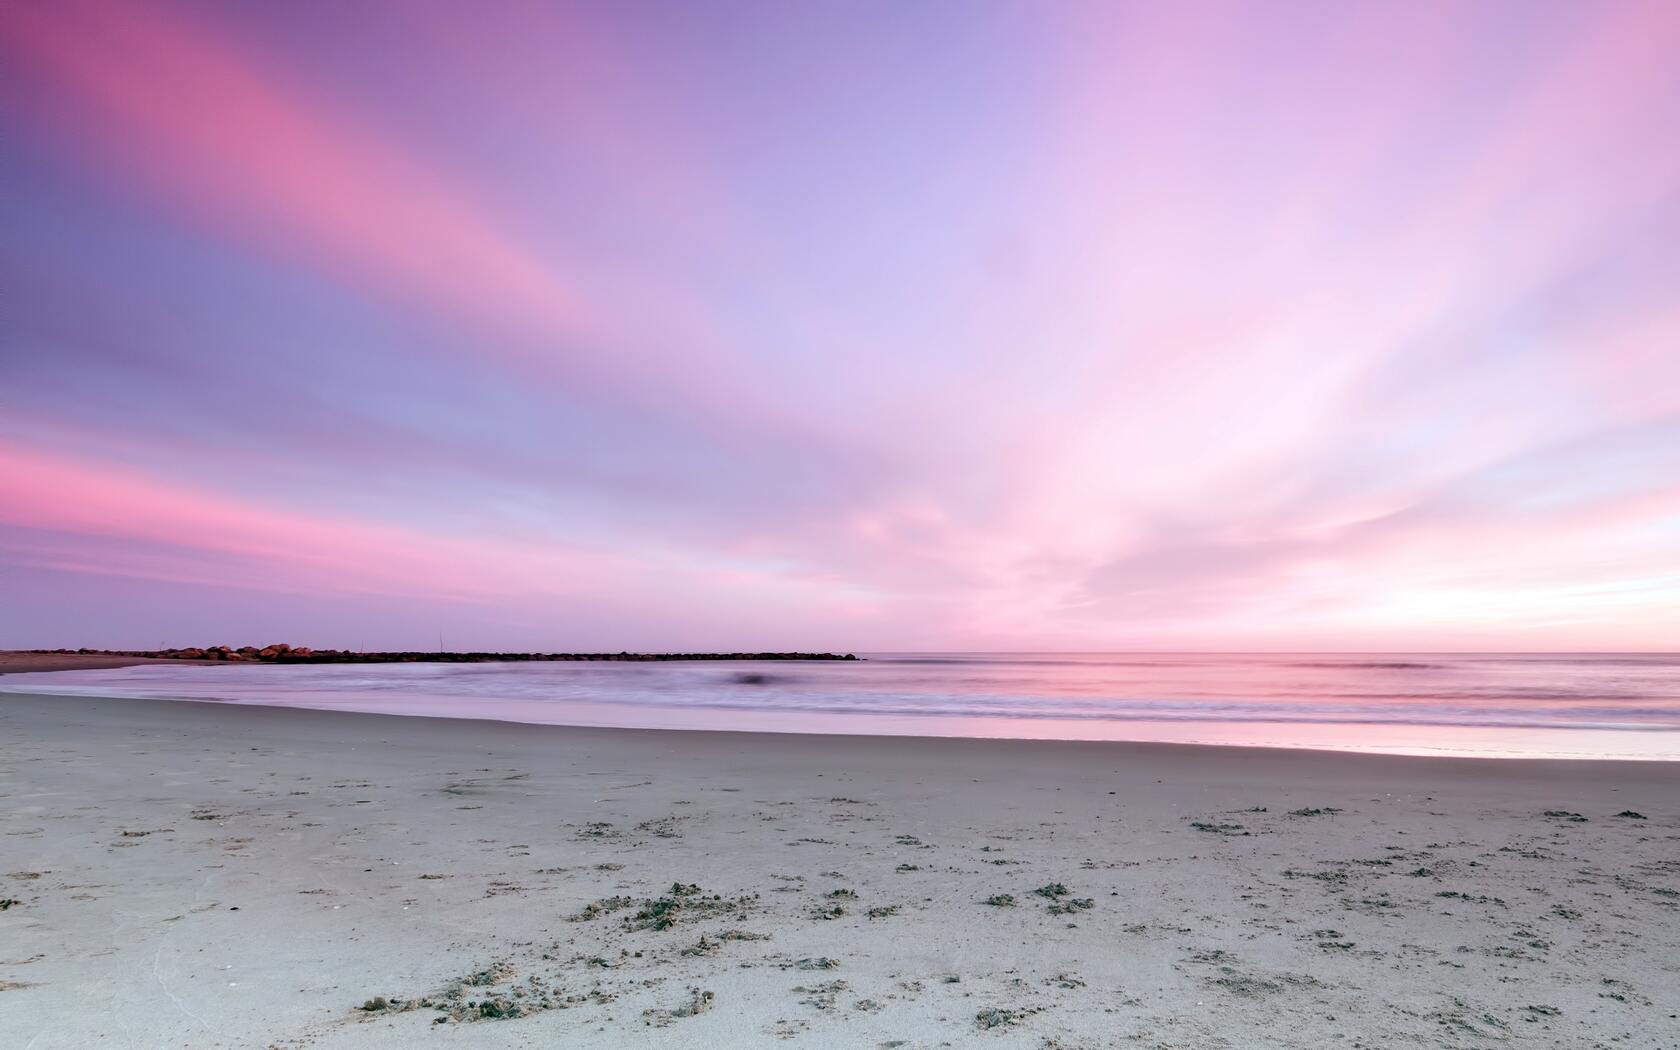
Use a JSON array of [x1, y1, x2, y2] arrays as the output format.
[[0, 0, 598, 347]]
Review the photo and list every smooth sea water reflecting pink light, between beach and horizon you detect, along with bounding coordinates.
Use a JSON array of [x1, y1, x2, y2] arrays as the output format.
[[0, 654, 1680, 759]]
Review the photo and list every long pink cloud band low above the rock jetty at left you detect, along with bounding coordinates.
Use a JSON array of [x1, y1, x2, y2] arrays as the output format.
[[0, 442, 920, 648]]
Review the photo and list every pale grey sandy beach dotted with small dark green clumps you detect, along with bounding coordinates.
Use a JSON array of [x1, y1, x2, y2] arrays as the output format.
[[0, 696, 1680, 1050]]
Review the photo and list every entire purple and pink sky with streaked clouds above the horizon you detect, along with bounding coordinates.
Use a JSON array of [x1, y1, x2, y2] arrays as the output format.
[[0, 0, 1680, 650]]
